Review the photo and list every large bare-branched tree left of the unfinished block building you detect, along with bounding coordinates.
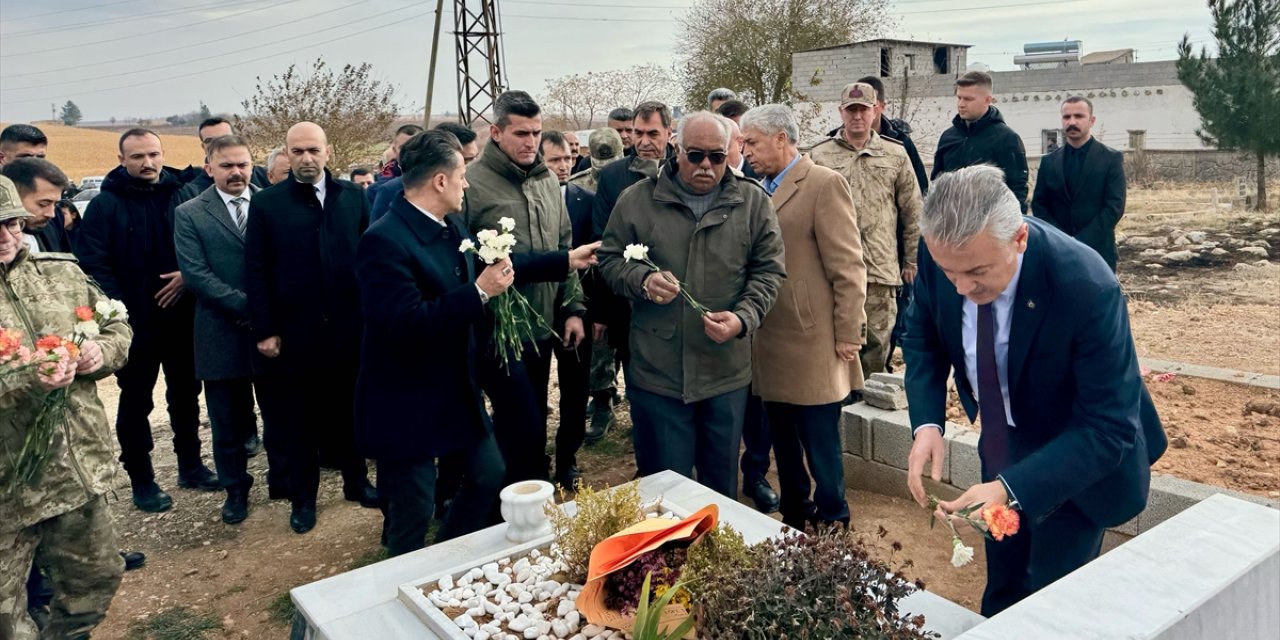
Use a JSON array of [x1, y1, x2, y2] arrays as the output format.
[[676, 0, 893, 109]]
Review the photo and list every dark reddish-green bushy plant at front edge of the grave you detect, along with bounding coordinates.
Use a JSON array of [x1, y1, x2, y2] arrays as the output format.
[[695, 529, 937, 640]]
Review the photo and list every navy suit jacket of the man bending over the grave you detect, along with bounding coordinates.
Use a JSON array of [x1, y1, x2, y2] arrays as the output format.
[[902, 218, 1167, 527]]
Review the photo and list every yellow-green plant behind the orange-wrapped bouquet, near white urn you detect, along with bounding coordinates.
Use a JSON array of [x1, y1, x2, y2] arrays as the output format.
[[547, 481, 644, 585]]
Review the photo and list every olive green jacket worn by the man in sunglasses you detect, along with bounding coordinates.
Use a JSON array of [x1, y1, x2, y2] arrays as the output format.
[[596, 160, 786, 403]]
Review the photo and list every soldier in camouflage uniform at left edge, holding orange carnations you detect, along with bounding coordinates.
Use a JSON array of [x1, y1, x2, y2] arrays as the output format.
[[0, 177, 133, 640]]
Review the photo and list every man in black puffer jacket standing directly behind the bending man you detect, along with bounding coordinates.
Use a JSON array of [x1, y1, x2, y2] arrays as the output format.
[[931, 72, 1027, 214]]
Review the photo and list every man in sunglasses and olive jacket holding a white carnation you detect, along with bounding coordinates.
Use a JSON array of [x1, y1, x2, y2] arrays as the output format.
[[599, 113, 786, 499]]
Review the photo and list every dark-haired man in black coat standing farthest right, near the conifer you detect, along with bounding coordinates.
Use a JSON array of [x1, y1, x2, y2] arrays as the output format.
[[1032, 96, 1125, 271]]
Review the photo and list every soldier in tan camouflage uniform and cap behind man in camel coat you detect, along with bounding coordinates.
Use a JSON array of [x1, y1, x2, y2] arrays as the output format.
[[809, 82, 922, 378]]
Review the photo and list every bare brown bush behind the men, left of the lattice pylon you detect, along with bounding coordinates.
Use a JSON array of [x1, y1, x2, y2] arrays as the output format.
[[236, 59, 399, 172]]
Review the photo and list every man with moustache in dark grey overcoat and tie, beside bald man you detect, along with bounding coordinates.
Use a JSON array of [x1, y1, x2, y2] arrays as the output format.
[[174, 136, 288, 525]]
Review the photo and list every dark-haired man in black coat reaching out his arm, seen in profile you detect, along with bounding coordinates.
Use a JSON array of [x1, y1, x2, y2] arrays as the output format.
[[356, 131, 594, 556]]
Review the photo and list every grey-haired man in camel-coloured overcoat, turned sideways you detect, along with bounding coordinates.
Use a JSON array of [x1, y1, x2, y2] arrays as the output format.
[[742, 105, 867, 530]]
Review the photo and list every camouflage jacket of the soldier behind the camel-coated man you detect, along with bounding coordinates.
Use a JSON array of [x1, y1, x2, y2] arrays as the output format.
[[809, 129, 922, 287]]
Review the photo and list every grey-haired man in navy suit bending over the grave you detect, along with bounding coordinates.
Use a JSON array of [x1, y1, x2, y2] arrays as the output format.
[[902, 165, 1166, 617]]
